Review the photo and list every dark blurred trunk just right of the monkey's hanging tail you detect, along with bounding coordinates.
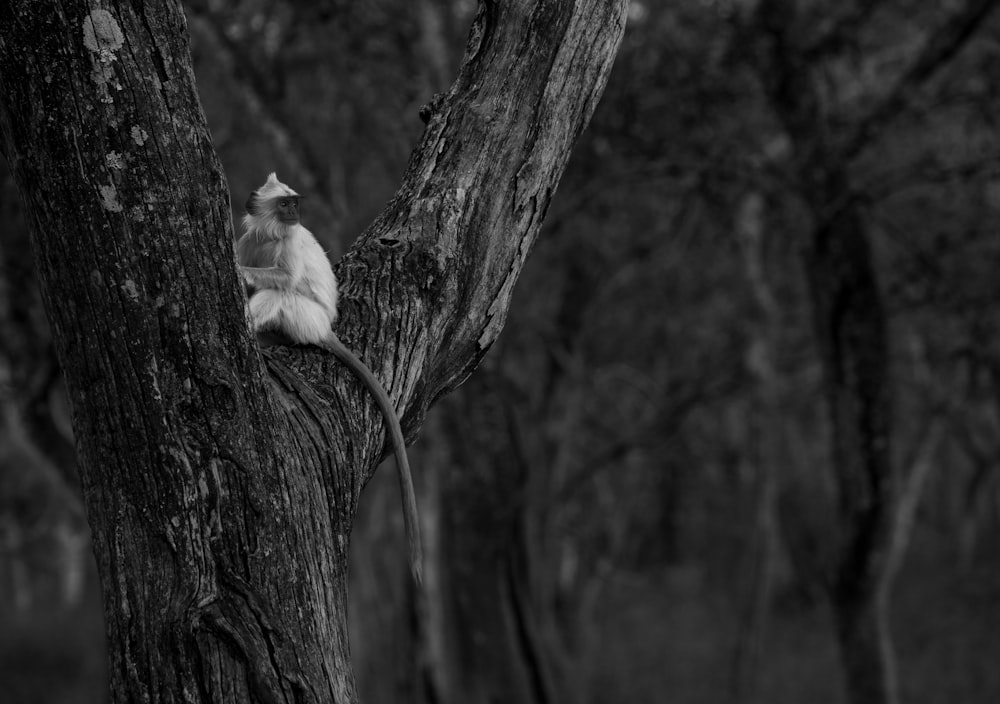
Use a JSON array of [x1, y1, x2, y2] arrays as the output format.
[[440, 380, 559, 704]]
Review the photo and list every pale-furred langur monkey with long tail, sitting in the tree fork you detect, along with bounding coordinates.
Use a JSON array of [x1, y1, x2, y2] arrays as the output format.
[[236, 173, 423, 586]]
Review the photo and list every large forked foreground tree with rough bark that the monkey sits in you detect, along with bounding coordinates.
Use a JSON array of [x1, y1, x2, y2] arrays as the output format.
[[0, 0, 626, 702]]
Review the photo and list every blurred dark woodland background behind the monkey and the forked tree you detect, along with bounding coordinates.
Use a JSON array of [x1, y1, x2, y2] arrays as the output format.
[[0, 0, 1000, 703]]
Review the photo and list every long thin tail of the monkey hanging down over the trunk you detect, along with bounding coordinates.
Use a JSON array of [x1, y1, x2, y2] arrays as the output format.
[[327, 333, 424, 587]]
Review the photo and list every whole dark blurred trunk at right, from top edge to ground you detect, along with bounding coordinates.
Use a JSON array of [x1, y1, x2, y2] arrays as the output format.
[[752, 0, 899, 704]]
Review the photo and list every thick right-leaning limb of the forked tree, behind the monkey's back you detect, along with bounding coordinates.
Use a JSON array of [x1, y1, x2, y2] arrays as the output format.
[[337, 0, 623, 440]]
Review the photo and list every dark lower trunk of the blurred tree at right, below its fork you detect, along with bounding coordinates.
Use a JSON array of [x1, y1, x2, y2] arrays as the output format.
[[807, 198, 898, 704]]
